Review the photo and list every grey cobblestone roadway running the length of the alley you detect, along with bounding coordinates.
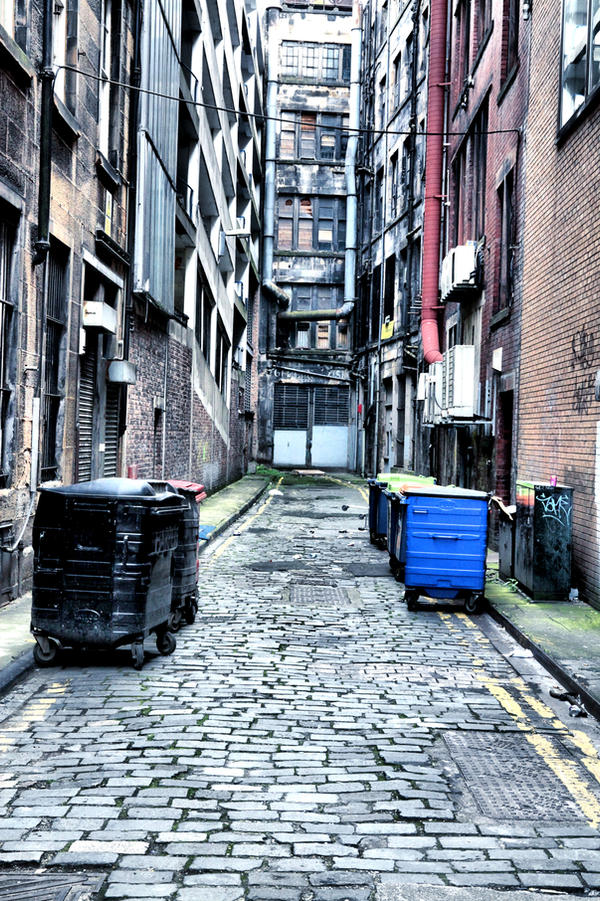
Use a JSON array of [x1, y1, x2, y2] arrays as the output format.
[[0, 480, 600, 901]]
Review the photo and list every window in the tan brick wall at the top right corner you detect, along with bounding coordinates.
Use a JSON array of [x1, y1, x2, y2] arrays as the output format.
[[560, 0, 600, 125]]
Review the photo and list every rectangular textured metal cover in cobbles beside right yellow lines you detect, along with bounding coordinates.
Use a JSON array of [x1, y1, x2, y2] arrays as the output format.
[[444, 732, 583, 822]]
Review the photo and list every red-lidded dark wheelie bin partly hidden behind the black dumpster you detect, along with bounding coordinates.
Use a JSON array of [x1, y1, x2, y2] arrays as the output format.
[[150, 479, 206, 630]]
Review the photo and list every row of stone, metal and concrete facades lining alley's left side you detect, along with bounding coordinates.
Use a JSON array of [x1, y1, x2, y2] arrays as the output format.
[[0, 0, 263, 603]]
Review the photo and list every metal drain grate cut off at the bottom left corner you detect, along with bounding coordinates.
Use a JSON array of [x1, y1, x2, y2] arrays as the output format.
[[0, 872, 104, 901]]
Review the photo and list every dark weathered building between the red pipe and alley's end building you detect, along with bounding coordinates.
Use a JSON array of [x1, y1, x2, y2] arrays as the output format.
[[356, 0, 429, 473]]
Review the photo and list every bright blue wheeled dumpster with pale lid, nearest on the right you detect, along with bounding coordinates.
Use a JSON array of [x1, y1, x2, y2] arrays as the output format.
[[394, 485, 488, 613]]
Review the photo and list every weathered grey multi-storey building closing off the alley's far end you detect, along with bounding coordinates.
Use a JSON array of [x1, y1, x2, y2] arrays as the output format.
[[257, 3, 360, 468]]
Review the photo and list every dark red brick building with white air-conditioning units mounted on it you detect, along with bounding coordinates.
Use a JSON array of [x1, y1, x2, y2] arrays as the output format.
[[418, 0, 532, 510]]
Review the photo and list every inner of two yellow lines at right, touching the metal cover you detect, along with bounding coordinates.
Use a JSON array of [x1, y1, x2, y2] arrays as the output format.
[[481, 673, 600, 829]]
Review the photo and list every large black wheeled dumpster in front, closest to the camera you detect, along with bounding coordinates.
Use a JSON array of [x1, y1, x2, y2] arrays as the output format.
[[31, 479, 184, 668]]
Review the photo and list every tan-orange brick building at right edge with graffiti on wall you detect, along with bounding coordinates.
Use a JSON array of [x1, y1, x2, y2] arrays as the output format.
[[518, 0, 600, 606]]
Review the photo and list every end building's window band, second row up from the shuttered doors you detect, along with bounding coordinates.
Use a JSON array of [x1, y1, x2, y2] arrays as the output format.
[[277, 196, 346, 253]]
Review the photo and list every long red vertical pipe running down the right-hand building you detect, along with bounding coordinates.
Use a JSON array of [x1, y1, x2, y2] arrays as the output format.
[[421, 0, 447, 363]]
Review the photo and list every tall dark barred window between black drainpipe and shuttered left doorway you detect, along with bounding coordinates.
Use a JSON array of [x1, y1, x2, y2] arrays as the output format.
[[41, 243, 68, 481]]
